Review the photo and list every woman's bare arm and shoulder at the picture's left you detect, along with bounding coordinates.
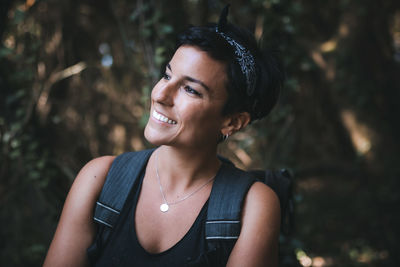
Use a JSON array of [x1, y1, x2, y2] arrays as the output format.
[[43, 156, 114, 267]]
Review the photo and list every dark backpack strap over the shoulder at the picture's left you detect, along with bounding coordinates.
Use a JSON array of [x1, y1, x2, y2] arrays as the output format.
[[88, 149, 154, 261]]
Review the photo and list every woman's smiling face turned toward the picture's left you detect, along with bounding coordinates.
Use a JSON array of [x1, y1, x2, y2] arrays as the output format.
[[145, 46, 227, 148]]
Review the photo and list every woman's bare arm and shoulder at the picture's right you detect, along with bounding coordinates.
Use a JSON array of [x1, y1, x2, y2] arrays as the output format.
[[227, 182, 280, 267]]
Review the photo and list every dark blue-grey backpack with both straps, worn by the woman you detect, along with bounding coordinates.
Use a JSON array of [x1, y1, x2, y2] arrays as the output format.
[[88, 149, 292, 266]]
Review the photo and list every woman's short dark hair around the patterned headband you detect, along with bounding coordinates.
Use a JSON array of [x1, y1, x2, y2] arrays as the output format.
[[177, 23, 285, 121]]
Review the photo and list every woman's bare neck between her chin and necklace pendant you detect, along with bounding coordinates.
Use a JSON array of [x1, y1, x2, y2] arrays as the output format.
[[155, 146, 221, 192]]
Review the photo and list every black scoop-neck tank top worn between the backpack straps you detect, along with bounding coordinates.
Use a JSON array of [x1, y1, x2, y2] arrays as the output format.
[[95, 172, 208, 267]]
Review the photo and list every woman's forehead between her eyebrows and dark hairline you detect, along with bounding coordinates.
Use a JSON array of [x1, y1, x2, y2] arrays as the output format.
[[170, 46, 226, 94]]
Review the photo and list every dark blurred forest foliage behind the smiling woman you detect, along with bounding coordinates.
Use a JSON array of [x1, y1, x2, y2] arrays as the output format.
[[0, 0, 400, 267]]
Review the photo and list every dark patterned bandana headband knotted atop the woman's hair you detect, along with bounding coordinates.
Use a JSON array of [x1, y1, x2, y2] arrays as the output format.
[[215, 5, 257, 96]]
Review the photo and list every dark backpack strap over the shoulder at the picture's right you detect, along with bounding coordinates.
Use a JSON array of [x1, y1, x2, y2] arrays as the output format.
[[205, 163, 256, 266]]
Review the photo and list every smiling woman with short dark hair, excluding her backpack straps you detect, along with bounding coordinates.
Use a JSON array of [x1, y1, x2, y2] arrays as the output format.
[[44, 8, 283, 266]]
